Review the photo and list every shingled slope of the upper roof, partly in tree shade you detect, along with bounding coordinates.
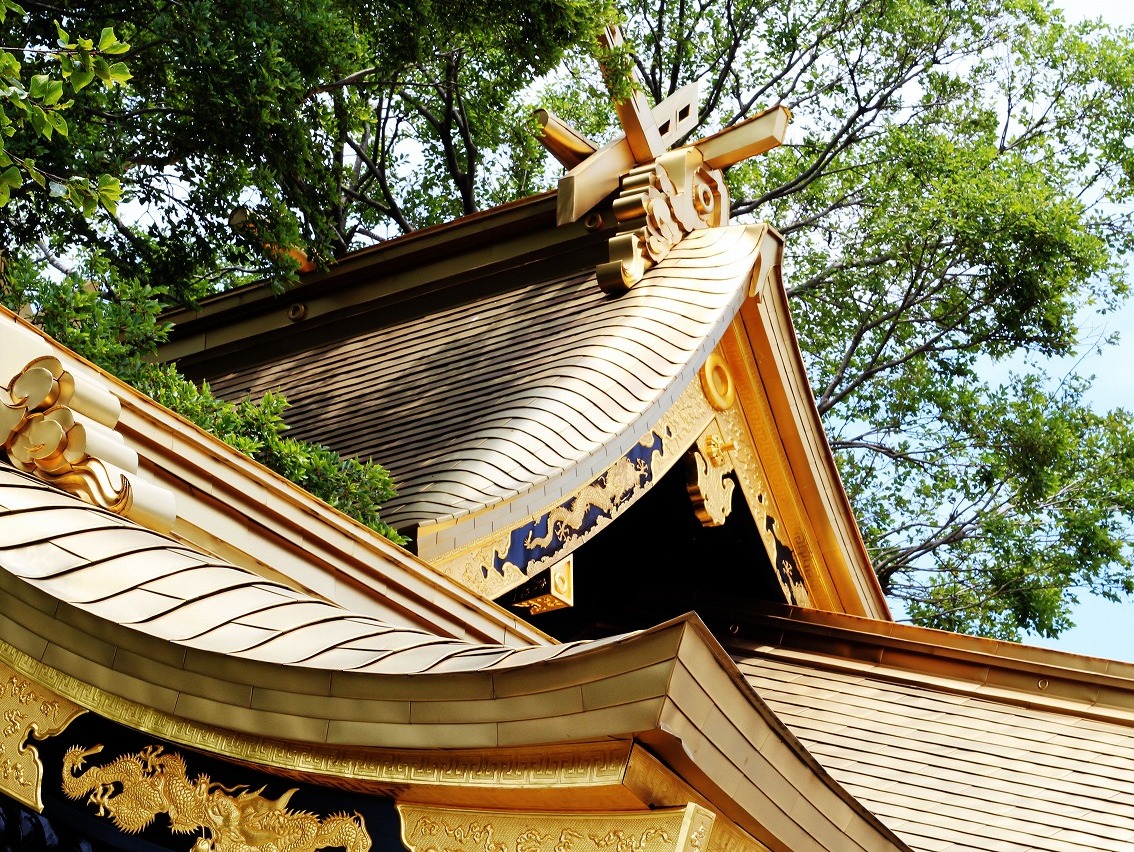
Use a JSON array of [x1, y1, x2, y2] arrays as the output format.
[[179, 226, 759, 529]]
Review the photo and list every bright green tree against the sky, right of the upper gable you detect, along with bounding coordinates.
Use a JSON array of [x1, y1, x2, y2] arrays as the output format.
[[550, 0, 1134, 638]]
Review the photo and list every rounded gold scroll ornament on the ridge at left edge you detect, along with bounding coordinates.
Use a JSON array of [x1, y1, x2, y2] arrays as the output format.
[[0, 355, 176, 532]]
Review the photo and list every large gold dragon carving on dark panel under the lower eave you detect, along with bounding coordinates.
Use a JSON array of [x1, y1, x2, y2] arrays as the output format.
[[62, 745, 372, 852]]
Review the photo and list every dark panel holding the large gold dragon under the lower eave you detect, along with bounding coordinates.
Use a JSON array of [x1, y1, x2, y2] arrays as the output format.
[[15, 714, 403, 852]]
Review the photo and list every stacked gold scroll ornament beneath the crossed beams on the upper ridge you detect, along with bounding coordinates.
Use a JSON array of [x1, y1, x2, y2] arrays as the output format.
[[598, 147, 729, 293]]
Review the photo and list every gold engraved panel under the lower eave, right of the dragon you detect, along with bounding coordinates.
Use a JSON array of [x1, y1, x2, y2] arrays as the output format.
[[398, 802, 717, 852]]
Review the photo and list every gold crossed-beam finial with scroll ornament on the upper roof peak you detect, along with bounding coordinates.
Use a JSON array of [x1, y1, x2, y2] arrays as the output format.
[[536, 26, 792, 293]]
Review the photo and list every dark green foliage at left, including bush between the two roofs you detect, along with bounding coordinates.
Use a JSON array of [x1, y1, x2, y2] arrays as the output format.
[[0, 0, 602, 541]]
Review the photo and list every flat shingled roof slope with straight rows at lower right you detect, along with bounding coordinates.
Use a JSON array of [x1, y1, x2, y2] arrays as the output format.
[[736, 653, 1134, 852]]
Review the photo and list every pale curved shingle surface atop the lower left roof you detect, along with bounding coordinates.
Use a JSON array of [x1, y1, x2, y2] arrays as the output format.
[[0, 465, 575, 674]]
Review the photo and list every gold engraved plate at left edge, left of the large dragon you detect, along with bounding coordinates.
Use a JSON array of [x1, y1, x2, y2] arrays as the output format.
[[0, 663, 86, 811]]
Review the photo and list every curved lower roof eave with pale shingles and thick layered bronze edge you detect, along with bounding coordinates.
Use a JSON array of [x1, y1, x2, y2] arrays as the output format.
[[0, 467, 905, 850]]
